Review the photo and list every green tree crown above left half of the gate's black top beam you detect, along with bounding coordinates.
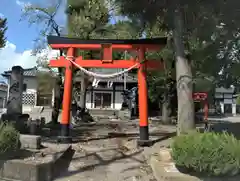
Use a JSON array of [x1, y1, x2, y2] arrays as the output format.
[[66, 0, 110, 39]]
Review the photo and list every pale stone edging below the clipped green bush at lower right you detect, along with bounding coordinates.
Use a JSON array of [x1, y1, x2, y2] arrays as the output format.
[[149, 155, 240, 181]]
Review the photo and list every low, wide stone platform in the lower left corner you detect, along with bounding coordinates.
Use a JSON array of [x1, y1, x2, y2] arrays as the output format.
[[0, 145, 71, 181]]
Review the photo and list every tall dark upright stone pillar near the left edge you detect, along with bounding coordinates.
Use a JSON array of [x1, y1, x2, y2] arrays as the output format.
[[7, 66, 23, 115]]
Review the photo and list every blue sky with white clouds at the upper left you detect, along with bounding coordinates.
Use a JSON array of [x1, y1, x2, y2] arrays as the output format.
[[0, 0, 66, 78]]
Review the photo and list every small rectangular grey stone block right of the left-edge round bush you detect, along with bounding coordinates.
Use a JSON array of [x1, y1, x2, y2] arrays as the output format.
[[20, 134, 41, 149]]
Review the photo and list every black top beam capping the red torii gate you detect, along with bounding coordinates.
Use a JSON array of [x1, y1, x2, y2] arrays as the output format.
[[47, 36, 167, 45]]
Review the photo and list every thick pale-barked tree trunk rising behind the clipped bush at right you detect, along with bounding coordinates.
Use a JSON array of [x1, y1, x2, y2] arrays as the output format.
[[173, 8, 195, 134]]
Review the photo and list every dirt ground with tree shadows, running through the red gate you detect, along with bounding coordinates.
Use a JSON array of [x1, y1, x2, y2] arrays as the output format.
[[52, 120, 175, 181]]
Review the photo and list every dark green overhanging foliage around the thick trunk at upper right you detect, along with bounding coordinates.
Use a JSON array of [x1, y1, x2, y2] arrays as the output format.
[[115, 0, 240, 91]]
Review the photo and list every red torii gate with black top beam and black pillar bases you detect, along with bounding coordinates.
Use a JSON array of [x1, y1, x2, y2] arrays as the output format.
[[48, 36, 167, 146]]
